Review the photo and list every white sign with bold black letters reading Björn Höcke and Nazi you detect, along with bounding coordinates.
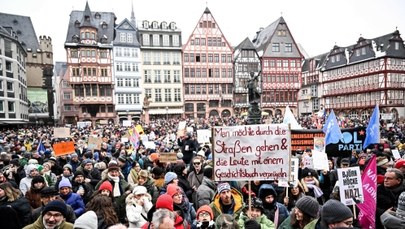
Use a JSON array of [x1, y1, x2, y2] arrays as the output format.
[[337, 166, 364, 205]]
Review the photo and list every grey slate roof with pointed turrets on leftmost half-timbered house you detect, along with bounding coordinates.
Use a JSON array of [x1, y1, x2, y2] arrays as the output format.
[[65, 3, 117, 43]]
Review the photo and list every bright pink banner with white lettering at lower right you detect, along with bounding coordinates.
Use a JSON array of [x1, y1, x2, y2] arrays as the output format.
[[357, 155, 377, 229]]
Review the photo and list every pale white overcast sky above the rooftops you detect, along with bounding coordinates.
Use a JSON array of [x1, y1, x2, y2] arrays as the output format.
[[0, 0, 405, 61]]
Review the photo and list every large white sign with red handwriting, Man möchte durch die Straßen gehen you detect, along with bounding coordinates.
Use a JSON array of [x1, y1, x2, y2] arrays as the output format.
[[214, 124, 291, 181]]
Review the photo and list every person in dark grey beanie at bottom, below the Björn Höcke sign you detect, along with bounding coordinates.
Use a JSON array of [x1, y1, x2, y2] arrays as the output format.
[[318, 199, 353, 228]]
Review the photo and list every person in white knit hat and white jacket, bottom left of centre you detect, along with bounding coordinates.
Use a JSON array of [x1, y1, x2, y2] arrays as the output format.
[[125, 185, 153, 228]]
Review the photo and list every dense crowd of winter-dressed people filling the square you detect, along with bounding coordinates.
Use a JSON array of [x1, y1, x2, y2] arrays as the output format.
[[0, 117, 405, 229]]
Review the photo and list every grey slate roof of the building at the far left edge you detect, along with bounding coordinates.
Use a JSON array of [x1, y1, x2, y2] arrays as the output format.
[[0, 13, 39, 53]]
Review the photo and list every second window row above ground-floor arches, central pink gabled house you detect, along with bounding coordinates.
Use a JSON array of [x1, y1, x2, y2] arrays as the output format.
[[184, 68, 233, 78]]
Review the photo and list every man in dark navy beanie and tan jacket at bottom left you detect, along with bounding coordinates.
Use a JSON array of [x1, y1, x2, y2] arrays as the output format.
[[23, 200, 73, 229]]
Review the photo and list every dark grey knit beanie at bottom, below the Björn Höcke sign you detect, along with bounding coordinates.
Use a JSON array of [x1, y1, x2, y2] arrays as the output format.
[[321, 199, 353, 225]]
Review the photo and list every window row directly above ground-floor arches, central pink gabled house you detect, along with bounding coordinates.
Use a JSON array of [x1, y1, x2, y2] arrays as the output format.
[[184, 84, 233, 95]]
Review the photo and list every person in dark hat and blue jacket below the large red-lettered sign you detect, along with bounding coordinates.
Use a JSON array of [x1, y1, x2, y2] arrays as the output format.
[[258, 184, 289, 226]]
